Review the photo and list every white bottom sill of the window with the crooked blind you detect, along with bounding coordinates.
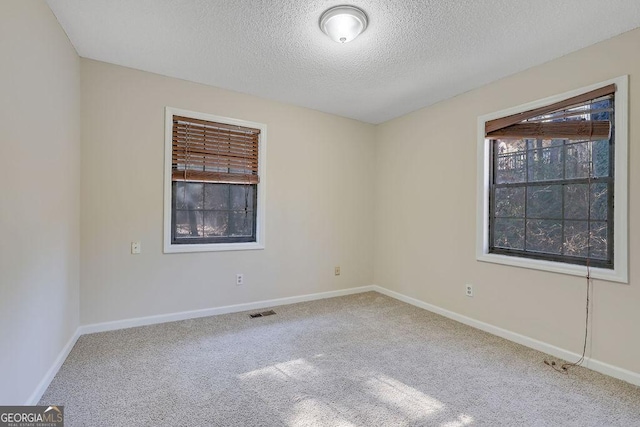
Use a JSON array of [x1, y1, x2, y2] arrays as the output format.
[[476, 253, 629, 283]]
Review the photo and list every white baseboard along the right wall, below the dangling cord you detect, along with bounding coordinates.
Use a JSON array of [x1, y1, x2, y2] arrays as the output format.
[[372, 285, 640, 386]]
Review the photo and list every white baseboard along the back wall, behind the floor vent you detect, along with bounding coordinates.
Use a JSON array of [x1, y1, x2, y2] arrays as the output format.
[[80, 286, 373, 335]]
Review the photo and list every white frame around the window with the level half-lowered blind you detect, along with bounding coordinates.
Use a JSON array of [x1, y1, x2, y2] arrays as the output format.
[[164, 107, 267, 253]]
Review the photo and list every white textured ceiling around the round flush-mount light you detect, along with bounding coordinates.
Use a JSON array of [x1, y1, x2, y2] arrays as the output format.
[[48, 0, 640, 123]]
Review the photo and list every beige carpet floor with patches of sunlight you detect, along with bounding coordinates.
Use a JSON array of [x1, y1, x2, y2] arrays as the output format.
[[40, 292, 640, 427]]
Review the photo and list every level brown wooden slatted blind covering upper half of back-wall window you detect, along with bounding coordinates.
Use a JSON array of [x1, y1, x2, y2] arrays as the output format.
[[172, 116, 260, 184]]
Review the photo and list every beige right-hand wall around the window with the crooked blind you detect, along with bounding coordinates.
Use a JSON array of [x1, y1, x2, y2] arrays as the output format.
[[374, 30, 640, 372]]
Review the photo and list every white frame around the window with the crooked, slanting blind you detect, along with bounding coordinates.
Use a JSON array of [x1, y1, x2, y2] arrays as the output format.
[[476, 75, 629, 283]]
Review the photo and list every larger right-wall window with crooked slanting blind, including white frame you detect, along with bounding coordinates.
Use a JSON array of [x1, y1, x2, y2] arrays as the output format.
[[478, 78, 627, 282]]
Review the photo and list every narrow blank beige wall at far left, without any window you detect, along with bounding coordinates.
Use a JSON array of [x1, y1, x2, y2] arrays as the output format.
[[0, 0, 80, 404]]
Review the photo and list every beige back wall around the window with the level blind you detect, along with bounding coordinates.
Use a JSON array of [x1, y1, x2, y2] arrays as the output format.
[[81, 59, 375, 324]]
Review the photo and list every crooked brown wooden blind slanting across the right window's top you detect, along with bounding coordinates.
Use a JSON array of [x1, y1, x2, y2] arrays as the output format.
[[485, 84, 616, 140]]
